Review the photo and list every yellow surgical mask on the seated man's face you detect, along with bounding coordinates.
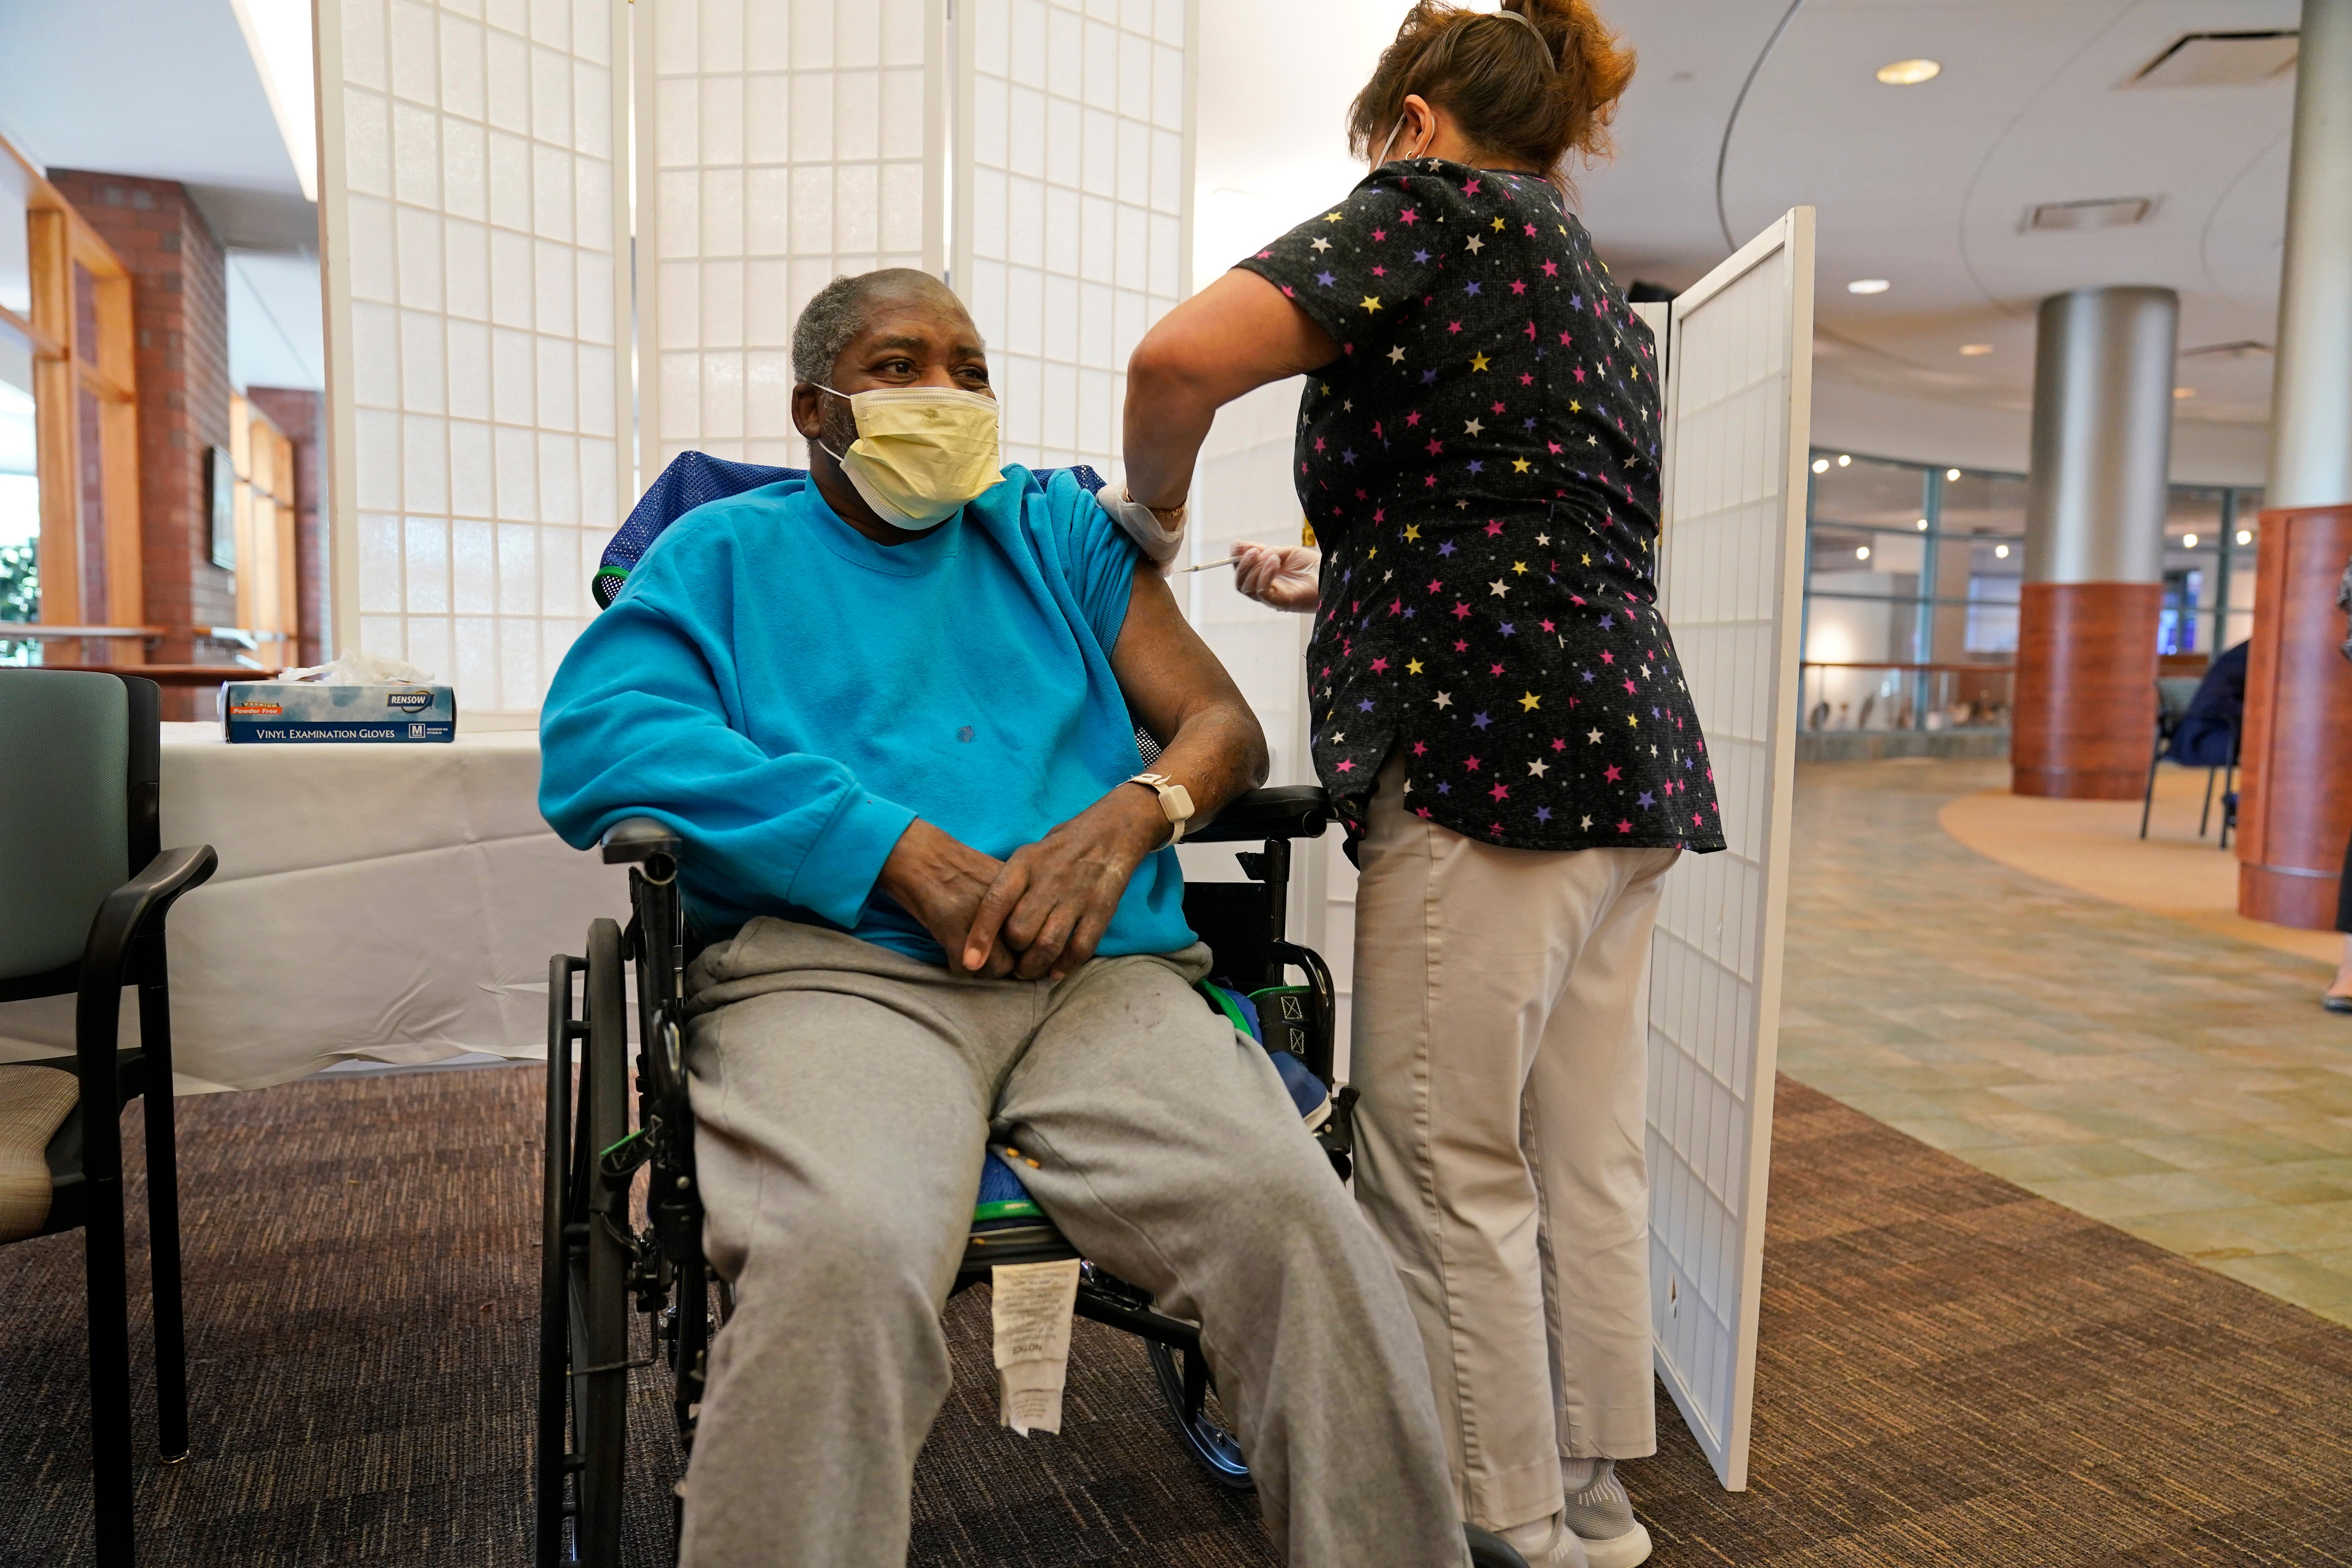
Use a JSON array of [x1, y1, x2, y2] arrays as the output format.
[[816, 383, 1004, 534]]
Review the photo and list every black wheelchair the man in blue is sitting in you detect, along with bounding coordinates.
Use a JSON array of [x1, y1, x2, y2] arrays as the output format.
[[534, 788, 1355, 1568]]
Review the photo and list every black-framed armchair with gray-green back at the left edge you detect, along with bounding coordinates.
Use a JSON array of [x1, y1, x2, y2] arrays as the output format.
[[0, 670, 219, 1568]]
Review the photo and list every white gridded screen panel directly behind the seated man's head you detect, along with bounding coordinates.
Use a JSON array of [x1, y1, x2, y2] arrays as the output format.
[[635, 0, 946, 479]]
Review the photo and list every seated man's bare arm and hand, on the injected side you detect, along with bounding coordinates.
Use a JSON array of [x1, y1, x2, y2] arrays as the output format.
[[962, 562, 1265, 980]]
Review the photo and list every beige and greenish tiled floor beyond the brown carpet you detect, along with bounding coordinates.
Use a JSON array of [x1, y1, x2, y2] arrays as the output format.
[[1780, 759, 2352, 1323]]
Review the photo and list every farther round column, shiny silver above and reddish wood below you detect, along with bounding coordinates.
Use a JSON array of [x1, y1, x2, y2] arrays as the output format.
[[2009, 287, 2180, 799]]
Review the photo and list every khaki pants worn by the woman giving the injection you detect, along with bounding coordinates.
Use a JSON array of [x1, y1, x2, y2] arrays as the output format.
[[1350, 764, 1682, 1530]]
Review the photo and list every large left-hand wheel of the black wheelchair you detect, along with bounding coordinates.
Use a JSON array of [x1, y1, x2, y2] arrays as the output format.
[[536, 919, 635, 1568]]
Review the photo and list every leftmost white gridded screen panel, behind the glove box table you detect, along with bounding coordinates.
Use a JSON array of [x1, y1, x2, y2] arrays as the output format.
[[318, 0, 628, 710]]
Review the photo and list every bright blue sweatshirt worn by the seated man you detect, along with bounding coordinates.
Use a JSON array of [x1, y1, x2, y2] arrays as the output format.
[[539, 465, 1192, 964]]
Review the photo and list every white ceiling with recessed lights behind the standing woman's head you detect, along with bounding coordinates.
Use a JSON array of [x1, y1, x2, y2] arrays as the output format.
[[1195, 0, 2296, 482]]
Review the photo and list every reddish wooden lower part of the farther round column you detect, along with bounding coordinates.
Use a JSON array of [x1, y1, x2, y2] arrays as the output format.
[[2009, 583, 2164, 799]]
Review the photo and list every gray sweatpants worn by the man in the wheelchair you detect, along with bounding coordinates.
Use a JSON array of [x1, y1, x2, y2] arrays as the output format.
[[682, 919, 1465, 1568]]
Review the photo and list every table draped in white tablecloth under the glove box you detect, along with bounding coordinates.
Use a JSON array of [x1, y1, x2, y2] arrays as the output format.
[[0, 724, 628, 1093]]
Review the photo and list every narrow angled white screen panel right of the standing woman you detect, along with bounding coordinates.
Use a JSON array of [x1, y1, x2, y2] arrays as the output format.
[[1649, 207, 1813, 1490]]
